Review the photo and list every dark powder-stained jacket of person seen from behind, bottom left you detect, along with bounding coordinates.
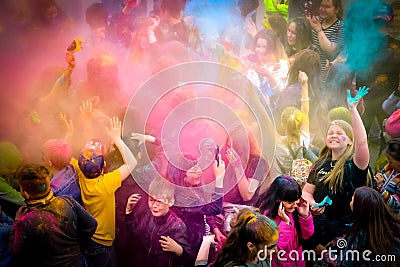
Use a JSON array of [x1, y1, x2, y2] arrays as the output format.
[[9, 195, 97, 267]]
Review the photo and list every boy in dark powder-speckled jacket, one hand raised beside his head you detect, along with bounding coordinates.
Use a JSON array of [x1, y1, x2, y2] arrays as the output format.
[[125, 177, 192, 267]]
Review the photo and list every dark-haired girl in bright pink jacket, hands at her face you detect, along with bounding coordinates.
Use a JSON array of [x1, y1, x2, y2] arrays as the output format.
[[256, 174, 314, 266]]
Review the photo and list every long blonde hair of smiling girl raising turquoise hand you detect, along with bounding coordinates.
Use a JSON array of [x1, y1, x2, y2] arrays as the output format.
[[316, 120, 354, 193]]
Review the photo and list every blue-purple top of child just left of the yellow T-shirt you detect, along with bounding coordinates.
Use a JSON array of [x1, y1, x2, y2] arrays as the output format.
[[50, 164, 82, 204]]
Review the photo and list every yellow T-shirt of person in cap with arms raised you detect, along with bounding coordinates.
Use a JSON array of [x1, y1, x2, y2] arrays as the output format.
[[71, 159, 122, 246]]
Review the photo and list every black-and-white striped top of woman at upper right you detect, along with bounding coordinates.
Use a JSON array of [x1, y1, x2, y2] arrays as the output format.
[[312, 19, 343, 88]]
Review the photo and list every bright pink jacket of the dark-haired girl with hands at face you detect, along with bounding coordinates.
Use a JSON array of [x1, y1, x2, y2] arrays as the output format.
[[272, 213, 314, 267]]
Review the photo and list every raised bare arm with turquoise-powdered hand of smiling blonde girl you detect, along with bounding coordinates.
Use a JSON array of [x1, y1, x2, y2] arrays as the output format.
[[347, 86, 369, 170]]
